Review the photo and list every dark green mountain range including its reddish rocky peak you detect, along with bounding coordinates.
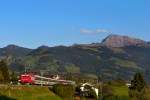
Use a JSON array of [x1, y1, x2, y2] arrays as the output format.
[[0, 35, 150, 82]]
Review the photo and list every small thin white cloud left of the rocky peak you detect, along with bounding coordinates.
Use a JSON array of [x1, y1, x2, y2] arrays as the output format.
[[80, 28, 111, 34]]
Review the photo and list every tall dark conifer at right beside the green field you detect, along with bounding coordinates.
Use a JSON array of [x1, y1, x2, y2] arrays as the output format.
[[129, 73, 146, 100]]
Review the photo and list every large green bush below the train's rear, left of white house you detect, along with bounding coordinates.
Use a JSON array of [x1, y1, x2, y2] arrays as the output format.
[[53, 84, 75, 100]]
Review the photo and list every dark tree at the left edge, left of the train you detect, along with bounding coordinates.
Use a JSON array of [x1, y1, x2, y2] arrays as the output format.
[[0, 60, 10, 82]]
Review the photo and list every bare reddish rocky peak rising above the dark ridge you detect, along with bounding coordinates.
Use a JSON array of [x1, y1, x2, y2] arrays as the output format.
[[102, 35, 146, 47]]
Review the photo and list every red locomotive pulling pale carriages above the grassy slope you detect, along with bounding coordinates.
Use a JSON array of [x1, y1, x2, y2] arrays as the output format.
[[18, 73, 75, 85]]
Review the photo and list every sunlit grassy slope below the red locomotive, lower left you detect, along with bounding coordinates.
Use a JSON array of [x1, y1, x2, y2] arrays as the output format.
[[0, 85, 62, 100]]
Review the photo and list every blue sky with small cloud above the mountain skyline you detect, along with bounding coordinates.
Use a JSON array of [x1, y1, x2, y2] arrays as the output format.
[[0, 0, 150, 48]]
